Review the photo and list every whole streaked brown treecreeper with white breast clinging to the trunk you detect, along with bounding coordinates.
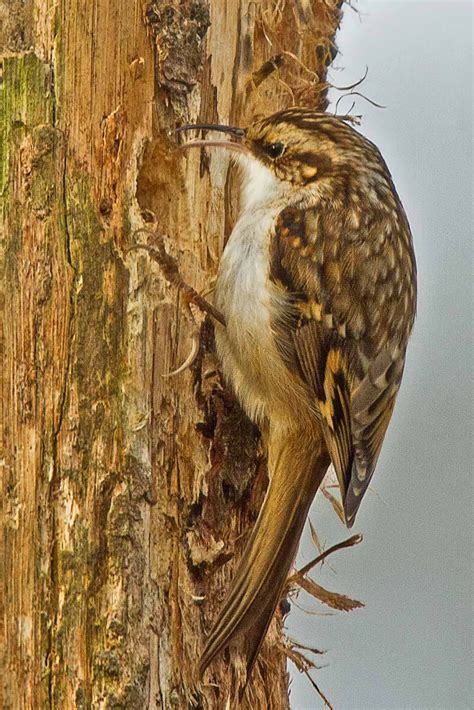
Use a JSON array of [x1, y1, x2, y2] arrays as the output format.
[[183, 108, 416, 677]]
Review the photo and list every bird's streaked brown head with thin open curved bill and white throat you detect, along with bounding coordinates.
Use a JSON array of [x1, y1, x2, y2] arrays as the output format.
[[178, 108, 386, 210]]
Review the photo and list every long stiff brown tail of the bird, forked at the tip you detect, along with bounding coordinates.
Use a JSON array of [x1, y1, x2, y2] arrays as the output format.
[[200, 434, 329, 678]]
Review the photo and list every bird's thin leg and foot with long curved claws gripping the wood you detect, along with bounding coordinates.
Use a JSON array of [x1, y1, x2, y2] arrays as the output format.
[[126, 228, 226, 377]]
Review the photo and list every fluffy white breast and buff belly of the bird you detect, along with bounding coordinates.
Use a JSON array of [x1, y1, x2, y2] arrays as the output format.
[[216, 159, 306, 422]]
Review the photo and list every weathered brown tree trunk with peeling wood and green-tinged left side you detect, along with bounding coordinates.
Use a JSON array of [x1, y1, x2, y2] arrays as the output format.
[[0, 0, 341, 710]]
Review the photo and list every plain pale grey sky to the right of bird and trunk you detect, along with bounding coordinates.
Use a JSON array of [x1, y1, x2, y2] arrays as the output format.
[[288, 0, 474, 710]]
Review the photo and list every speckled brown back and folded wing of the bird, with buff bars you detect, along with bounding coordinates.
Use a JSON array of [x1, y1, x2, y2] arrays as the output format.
[[272, 206, 416, 526]]
